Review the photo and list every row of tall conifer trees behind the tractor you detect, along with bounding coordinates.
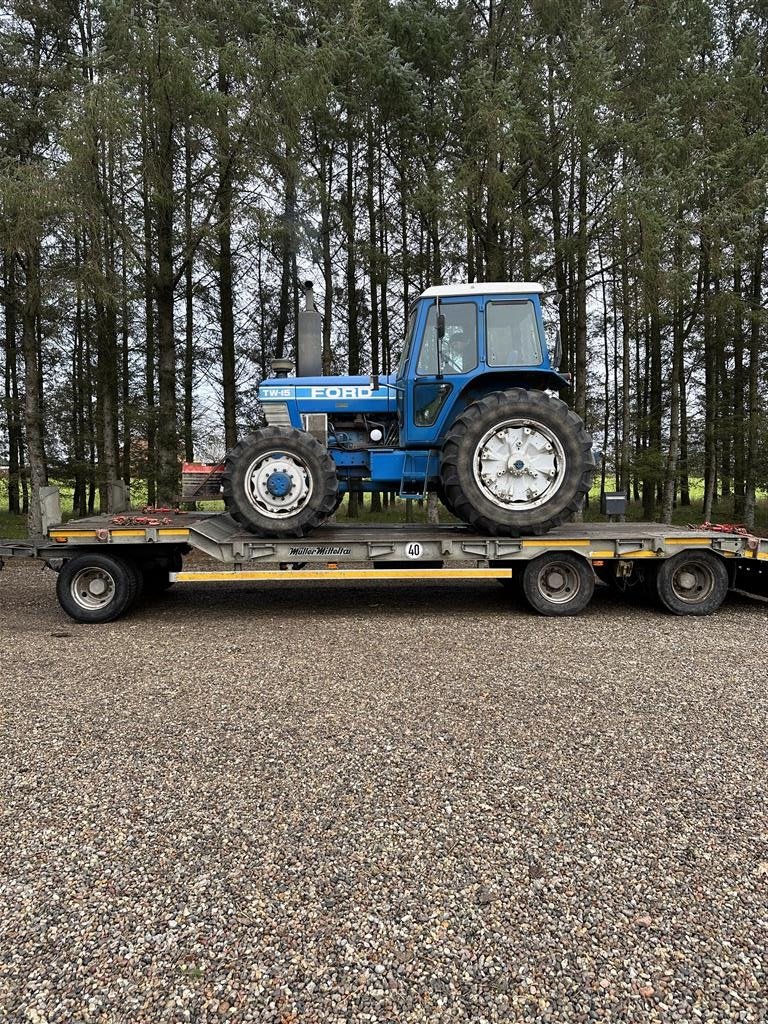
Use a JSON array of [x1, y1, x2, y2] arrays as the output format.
[[0, 0, 768, 531]]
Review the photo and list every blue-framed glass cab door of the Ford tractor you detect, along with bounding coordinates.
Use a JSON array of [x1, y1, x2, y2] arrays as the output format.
[[398, 298, 481, 447]]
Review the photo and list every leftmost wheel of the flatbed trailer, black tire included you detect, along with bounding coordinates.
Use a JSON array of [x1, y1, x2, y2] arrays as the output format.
[[56, 551, 141, 623]]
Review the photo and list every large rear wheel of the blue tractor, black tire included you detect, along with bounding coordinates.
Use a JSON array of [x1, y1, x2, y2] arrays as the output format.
[[440, 388, 595, 537]]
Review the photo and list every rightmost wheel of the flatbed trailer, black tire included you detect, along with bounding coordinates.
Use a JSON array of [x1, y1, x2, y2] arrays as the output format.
[[656, 551, 728, 615]]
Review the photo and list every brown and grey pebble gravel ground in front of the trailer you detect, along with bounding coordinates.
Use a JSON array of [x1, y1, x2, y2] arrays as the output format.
[[0, 564, 768, 1024]]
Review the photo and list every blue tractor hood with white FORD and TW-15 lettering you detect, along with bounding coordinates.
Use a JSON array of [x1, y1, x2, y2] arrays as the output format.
[[259, 374, 395, 428]]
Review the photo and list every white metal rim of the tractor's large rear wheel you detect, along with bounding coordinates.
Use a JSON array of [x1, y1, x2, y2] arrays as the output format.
[[472, 419, 565, 512]]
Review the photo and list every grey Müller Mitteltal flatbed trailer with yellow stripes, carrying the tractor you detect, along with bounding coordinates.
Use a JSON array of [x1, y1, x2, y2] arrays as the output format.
[[0, 509, 768, 623]]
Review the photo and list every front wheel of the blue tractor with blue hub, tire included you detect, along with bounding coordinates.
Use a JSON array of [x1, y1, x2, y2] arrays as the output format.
[[223, 427, 339, 537]]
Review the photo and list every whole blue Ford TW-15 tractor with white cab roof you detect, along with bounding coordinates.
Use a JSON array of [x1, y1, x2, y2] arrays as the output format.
[[222, 283, 595, 537]]
